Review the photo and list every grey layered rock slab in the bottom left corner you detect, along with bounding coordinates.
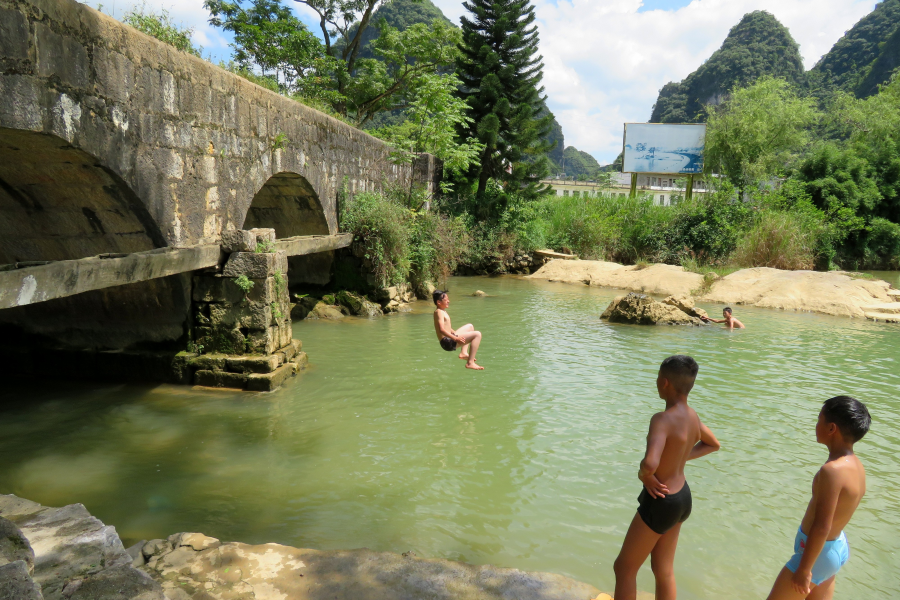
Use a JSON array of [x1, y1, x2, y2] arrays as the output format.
[[0, 495, 166, 600]]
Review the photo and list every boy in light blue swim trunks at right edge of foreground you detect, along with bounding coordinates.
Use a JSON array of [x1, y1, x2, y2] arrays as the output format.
[[769, 396, 872, 600]]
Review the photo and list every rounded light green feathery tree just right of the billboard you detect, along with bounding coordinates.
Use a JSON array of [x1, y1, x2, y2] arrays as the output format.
[[705, 77, 821, 194]]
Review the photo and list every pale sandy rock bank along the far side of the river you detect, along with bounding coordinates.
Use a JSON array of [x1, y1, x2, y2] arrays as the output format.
[[529, 260, 900, 320]]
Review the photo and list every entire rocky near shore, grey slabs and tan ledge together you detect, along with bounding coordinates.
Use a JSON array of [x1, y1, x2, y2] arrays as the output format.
[[0, 495, 611, 600]]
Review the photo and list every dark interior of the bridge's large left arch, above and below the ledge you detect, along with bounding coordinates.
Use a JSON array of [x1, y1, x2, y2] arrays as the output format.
[[0, 128, 190, 349]]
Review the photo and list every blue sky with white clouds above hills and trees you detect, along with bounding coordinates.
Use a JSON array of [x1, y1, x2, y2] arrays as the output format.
[[95, 0, 875, 164]]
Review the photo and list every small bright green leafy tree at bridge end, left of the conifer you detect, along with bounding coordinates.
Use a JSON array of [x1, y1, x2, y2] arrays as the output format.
[[371, 74, 483, 193]]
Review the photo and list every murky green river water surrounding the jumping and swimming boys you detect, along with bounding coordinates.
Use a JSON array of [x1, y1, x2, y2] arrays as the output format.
[[0, 277, 900, 600]]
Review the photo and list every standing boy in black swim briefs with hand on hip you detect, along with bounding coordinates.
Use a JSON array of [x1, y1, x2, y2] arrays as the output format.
[[613, 356, 719, 600]]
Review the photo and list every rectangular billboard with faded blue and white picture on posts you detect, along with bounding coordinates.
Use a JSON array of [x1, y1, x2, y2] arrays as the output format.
[[622, 123, 706, 175]]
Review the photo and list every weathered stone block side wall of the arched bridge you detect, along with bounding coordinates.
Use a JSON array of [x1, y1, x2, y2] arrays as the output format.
[[0, 0, 435, 251]]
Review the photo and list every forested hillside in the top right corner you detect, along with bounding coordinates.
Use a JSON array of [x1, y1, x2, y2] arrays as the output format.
[[809, 0, 900, 98]]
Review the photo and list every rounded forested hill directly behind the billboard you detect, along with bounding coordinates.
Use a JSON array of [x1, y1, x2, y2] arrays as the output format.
[[650, 11, 804, 123]]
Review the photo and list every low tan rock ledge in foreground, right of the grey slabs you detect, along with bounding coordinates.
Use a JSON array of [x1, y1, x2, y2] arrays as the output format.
[[142, 533, 604, 600]]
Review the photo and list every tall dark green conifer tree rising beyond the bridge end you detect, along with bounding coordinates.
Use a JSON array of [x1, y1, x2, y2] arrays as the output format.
[[457, 0, 553, 200]]
